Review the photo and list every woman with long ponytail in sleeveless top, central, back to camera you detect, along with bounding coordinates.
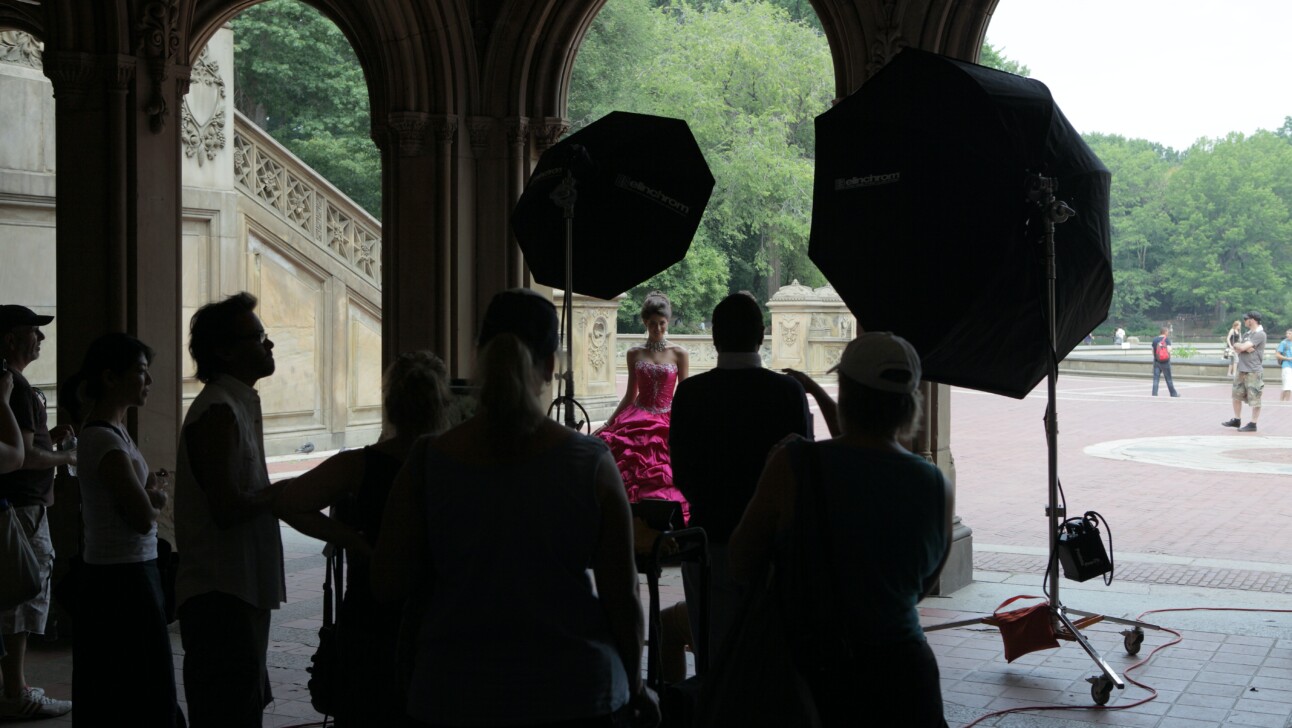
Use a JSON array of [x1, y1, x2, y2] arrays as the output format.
[[372, 290, 658, 728]]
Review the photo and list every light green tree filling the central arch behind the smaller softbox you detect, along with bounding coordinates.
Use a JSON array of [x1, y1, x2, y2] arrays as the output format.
[[568, 0, 833, 323]]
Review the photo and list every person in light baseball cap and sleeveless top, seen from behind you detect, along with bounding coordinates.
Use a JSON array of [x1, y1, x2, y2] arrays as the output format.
[[730, 332, 955, 728]]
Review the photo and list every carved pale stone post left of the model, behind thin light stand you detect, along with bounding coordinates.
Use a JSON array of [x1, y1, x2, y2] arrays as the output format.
[[552, 290, 623, 422]]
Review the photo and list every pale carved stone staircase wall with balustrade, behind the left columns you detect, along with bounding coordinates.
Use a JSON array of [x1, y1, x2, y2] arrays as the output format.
[[0, 30, 381, 464]]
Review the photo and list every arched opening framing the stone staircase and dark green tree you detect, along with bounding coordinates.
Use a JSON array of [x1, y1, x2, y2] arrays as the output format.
[[181, 0, 382, 455]]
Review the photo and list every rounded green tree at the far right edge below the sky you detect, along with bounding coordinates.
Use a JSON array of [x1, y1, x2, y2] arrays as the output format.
[[1160, 131, 1292, 319]]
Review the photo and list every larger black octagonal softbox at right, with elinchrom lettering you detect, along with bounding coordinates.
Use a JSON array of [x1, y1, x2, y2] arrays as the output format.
[[809, 49, 1112, 398]]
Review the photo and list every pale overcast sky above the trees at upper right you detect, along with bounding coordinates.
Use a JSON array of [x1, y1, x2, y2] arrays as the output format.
[[987, 0, 1292, 150]]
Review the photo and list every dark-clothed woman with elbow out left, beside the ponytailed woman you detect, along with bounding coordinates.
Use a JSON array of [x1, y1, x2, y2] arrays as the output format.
[[274, 350, 448, 728]]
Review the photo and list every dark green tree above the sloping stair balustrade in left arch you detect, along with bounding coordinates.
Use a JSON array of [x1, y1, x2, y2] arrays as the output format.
[[230, 0, 381, 217]]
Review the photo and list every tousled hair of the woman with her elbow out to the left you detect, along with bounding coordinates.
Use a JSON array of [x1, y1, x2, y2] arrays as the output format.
[[381, 349, 450, 436]]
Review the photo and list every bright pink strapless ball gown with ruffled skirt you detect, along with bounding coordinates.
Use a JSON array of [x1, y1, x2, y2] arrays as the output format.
[[597, 361, 691, 519]]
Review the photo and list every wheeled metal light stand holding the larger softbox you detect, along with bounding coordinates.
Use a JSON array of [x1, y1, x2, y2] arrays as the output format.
[[924, 175, 1162, 705]]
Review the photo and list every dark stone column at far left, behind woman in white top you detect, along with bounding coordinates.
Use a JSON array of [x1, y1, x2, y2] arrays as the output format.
[[45, 39, 189, 467]]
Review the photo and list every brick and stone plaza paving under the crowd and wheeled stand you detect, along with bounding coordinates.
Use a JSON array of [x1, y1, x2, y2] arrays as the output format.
[[17, 376, 1292, 728]]
